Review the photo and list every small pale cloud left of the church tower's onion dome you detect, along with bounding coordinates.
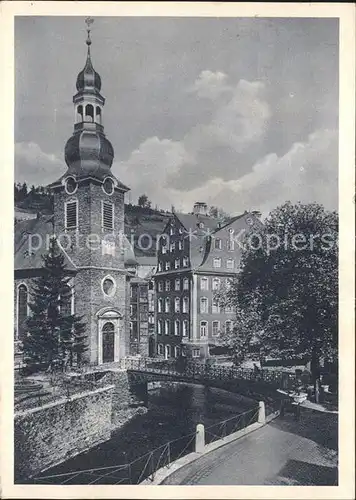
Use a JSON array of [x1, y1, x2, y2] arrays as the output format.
[[15, 142, 66, 186]]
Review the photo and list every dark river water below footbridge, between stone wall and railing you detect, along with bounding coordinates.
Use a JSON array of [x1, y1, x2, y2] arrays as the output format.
[[34, 383, 256, 484]]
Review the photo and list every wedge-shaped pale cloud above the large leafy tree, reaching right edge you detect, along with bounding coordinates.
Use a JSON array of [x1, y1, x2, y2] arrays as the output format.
[[179, 129, 338, 215]]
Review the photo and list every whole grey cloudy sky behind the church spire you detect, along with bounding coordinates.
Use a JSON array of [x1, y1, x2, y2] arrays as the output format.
[[15, 17, 338, 214]]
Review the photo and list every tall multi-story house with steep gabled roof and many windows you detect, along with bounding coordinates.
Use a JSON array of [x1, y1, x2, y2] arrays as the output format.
[[154, 202, 262, 358]]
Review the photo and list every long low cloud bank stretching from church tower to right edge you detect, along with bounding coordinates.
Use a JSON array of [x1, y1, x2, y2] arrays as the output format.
[[120, 129, 338, 215]]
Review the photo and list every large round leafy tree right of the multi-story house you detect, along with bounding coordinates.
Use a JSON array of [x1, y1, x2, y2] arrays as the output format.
[[221, 202, 338, 400]]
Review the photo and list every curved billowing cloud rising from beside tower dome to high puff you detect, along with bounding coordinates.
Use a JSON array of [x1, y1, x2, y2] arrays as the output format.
[[120, 70, 271, 199]]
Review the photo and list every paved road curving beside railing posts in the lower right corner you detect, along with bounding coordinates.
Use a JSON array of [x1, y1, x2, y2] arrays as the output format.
[[163, 409, 337, 485]]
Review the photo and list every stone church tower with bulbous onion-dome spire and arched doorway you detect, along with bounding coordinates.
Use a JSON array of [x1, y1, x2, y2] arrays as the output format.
[[50, 18, 134, 364]]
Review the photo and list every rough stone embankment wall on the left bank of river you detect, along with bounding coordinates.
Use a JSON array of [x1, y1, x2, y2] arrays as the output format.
[[14, 385, 114, 482]]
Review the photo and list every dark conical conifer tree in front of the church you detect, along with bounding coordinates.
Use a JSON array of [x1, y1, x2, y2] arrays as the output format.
[[23, 237, 87, 367]]
